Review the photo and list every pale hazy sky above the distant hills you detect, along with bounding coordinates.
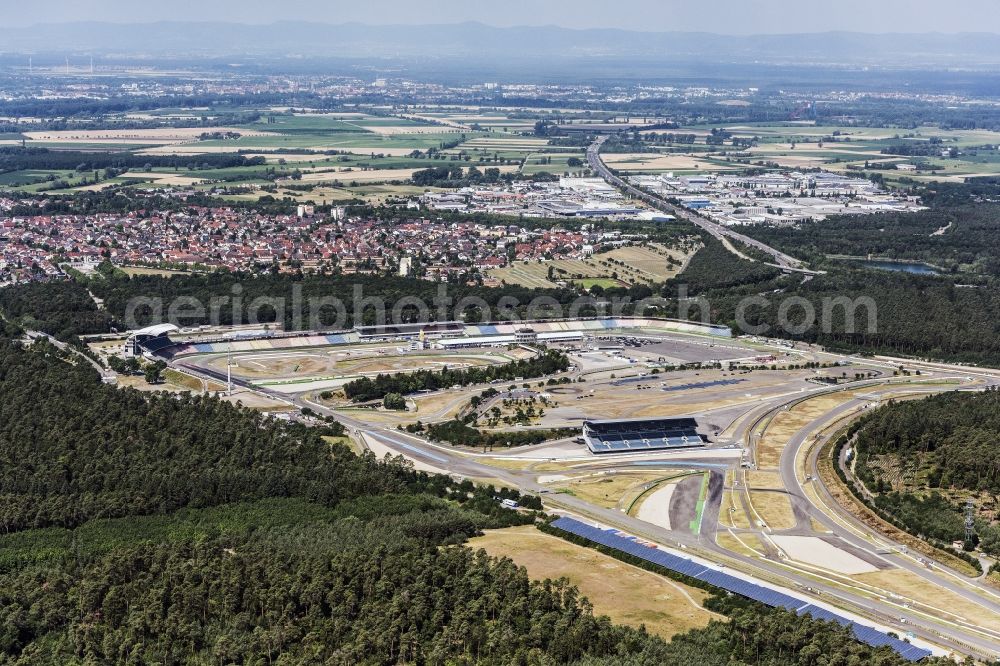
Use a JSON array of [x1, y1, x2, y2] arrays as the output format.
[[0, 0, 1000, 34]]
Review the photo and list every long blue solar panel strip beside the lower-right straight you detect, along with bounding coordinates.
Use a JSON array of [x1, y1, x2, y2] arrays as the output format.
[[552, 517, 931, 661]]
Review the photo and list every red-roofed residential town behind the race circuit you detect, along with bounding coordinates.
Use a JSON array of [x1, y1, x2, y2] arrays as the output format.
[[0, 193, 628, 284]]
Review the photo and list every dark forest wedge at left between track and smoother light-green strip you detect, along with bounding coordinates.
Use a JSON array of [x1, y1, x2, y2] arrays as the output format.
[[0, 341, 504, 532]]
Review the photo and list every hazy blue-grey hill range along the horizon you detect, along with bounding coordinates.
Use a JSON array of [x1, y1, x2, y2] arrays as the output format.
[[2, 21, 1000, 67]]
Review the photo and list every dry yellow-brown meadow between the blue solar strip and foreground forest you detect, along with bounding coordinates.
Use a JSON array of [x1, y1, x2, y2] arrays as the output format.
[[469, 526, 718, 638]]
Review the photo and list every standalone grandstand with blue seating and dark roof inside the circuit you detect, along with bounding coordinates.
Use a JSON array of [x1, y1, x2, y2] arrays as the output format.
[[583, 418, 707, 453]]
